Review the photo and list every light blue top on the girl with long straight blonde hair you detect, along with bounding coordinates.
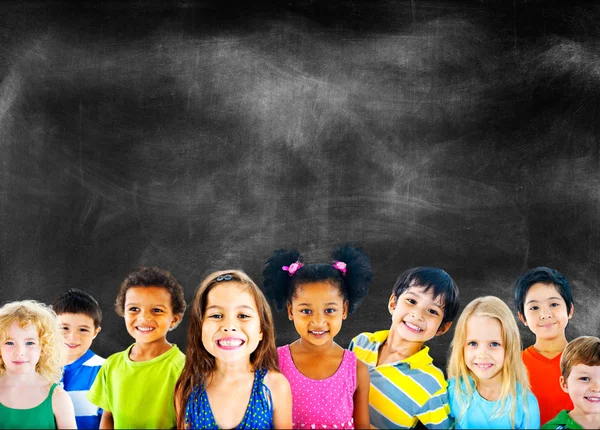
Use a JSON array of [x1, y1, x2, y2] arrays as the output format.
[[448, 377, 540, 429]]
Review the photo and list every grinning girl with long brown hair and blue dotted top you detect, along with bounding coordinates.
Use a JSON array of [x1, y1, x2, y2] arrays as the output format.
[[175, 270, 292, 429]]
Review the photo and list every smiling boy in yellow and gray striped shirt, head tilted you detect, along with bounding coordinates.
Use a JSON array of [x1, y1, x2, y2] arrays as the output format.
[[348, 267, 460, 429]]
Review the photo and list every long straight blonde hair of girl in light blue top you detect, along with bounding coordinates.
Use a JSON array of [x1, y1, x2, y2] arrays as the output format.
[[448, 296, 529, 427]]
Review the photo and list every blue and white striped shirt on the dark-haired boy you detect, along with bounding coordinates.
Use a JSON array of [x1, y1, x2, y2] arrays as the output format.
[[61, 349, 106, 429]]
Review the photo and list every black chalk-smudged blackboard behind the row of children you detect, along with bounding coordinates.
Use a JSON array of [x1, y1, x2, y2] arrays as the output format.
[[0, 0, 600, 368]]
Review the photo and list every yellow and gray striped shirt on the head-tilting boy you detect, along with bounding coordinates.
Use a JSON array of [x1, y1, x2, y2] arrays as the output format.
[[348, 330, 452, 429]]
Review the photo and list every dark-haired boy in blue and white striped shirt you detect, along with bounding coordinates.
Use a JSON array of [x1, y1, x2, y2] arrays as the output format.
[[52, 288, 105, 429]]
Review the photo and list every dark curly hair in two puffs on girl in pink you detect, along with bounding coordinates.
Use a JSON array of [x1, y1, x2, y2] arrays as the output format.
[[263, 245, 373, 315]]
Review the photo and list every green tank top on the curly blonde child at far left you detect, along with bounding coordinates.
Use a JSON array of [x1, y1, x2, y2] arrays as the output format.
[[0, 384, 58, 429]]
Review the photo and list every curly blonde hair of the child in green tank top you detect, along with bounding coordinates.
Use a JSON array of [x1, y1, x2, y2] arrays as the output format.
[[0, 300, 66, 383]]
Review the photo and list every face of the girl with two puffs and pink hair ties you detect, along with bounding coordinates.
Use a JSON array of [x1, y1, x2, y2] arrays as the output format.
[[287, 282, 348, 345]]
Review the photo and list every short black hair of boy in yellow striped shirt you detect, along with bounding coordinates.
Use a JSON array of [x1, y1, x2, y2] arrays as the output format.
[[392, 267, 460, 327]]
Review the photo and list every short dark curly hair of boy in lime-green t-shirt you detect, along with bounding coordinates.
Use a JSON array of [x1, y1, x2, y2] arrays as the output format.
[[115, 267, 187, 316]]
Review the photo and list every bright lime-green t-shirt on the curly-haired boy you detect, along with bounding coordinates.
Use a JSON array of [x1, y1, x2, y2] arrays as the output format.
[[87, 344, 185, 429]]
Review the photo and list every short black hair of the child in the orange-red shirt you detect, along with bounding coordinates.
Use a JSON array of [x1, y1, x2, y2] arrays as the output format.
[[515, 266, 573, 315]]
